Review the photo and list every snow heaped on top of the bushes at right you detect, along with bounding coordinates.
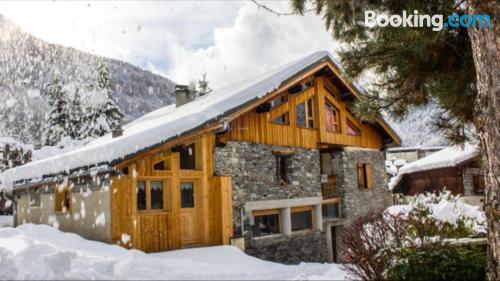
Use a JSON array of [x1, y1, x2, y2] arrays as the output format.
[[386, 191, 486, 233]]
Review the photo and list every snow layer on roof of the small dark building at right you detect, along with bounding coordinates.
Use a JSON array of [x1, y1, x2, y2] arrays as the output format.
[[389, 143, 481, 189]]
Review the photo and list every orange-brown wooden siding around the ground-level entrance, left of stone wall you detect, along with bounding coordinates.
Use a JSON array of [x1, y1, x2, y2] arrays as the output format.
[[111, 133, 232, 252]]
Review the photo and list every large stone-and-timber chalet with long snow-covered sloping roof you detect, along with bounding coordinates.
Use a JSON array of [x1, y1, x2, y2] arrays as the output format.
[[1, 52, 400, 263]]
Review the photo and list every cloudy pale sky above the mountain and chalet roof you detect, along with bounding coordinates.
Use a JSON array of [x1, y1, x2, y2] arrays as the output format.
[[0, 1, 338, 88]]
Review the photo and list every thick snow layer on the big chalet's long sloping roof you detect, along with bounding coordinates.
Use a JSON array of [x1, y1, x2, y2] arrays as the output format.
[[0, 51, 399, 189]]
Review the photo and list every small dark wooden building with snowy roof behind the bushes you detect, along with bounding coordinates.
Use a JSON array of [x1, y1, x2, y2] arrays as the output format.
[[389, 144, 484, 200]]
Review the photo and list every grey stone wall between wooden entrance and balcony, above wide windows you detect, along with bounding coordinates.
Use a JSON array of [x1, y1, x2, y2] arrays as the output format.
[[214, 141, 321, 230]]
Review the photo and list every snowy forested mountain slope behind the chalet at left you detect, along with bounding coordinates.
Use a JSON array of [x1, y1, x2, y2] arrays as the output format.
[[0, 15, 175, 144]]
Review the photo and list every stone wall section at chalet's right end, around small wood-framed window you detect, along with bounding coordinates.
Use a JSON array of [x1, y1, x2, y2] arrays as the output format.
[[323, 147, 392, 223]]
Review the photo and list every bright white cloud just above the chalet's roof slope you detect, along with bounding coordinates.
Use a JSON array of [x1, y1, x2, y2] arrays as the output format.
[[167, 2, 338, 88]]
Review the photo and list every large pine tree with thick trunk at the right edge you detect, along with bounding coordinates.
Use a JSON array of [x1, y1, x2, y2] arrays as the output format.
[[292, 0, 500, 280]]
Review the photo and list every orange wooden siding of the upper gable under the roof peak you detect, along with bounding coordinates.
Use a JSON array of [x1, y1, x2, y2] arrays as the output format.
[[225, 74, 382, 149]]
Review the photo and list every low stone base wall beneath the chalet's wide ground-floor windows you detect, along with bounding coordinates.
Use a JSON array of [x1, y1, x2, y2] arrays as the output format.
[[245, 231, 328, 264]]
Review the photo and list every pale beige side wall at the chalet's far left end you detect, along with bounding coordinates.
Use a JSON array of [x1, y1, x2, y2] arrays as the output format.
[[15, 176, 111, 243]]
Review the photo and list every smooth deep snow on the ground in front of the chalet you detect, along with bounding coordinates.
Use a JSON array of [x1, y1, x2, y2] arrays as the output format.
[[0, 224, 346, 280]]
